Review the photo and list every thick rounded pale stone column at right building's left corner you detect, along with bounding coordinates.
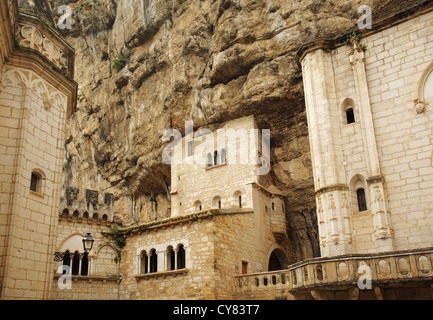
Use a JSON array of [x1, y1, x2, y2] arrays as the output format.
[[302, 49, 352, 256]]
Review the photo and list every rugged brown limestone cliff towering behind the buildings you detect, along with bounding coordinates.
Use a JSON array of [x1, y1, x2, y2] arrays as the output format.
[[17, 0, 418, 259]]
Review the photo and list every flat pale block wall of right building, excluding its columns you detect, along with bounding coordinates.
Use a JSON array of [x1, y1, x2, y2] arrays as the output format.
[[332, 12, 433, 252]]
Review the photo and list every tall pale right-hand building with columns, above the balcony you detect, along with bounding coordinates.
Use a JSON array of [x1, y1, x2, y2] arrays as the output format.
[[301, 3, 433, 257]]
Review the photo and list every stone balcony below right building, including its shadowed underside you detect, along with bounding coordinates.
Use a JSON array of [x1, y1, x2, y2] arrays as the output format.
[[236, 248, 433, 300]]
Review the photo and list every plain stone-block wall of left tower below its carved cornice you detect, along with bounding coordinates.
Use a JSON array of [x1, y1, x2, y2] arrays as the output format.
[[0, 66, 67, 299]]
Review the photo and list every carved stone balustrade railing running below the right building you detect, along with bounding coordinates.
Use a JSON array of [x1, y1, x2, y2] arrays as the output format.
[[236, 248, 433, 299]]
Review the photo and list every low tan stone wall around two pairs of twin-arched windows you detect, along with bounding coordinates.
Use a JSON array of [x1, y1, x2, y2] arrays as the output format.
[[120, 215, 216, 300]]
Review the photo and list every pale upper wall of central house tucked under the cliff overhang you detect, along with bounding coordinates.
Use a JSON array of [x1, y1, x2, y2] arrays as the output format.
[[171, 117, 261, 216]]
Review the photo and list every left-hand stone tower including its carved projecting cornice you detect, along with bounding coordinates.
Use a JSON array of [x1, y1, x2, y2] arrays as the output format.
[[0, 1, 77, 299]]
